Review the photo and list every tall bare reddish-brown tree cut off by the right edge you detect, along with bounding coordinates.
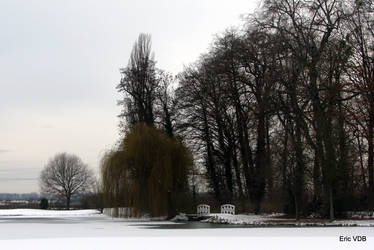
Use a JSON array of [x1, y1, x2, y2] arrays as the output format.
[[347, 0, 374, 208]]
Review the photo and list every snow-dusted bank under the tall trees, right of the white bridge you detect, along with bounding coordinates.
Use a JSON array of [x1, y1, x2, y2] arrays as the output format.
[[203, 214, 374, 227]]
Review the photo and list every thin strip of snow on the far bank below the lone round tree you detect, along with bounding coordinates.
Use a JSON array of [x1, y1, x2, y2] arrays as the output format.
[[0, 209, 100, 218]]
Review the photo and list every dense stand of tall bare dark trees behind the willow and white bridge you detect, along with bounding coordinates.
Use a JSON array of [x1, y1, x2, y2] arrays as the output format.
[[103, 0, 374, 220]]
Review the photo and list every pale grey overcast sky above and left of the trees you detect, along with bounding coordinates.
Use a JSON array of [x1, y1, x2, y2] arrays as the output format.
[[0, 0, 257, 193]]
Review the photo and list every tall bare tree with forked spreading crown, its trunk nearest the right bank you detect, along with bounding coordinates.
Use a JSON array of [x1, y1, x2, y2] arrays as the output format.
[[260, 0, 350, 220]]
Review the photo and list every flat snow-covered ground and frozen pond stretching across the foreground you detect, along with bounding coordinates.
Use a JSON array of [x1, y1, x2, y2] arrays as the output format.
[[0, 209, 374, 250]]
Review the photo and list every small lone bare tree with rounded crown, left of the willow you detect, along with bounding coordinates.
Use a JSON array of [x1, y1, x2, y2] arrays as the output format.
[[39, 153, 94, 209]]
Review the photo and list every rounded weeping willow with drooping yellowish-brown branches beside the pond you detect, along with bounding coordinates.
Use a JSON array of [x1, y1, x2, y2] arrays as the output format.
[[102, 124, 192, 217]]
